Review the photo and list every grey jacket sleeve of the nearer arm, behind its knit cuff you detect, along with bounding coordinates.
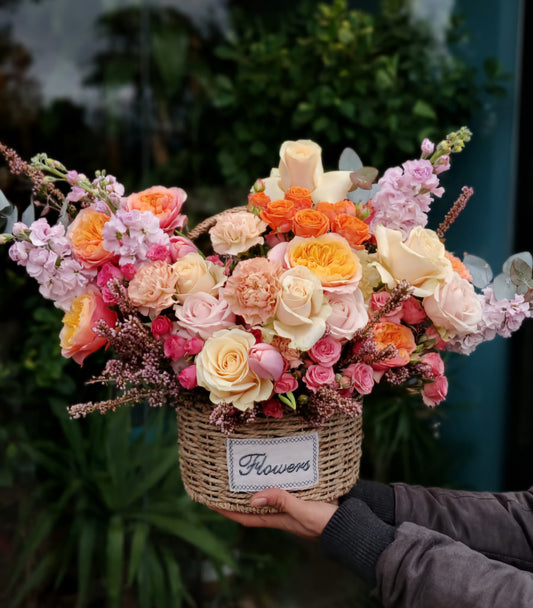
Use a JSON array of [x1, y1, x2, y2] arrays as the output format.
[[377, 523, 533, 608]]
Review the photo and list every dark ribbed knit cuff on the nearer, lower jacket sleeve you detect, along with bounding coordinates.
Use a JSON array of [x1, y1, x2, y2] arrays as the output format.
[[320, 498, 395, 586]]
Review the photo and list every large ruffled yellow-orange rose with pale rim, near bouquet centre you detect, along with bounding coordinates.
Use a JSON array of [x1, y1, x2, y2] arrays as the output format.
[[286, 233, 362, 293]]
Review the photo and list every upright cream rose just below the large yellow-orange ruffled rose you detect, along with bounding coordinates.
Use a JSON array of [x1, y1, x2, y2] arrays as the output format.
[[273, 266, 331, 350]]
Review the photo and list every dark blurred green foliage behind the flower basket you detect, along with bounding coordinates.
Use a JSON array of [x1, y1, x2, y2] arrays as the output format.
[[0, 0, 504, 608]]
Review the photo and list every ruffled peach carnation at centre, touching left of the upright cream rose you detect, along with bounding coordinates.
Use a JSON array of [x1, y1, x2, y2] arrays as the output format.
[[222, 258, 282, 325]]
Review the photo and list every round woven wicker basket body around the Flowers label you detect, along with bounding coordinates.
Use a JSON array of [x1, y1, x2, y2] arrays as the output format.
[[177, 403, 363, 513]]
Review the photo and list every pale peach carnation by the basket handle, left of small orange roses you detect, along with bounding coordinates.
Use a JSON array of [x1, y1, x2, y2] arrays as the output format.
[[209, 211, 267, 255]]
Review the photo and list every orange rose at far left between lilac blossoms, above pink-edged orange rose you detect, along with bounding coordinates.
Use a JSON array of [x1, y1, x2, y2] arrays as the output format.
[[67, 207, 114, 268]]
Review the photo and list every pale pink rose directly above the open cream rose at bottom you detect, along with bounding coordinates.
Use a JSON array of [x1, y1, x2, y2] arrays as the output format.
[[174, 292, 235, 340]]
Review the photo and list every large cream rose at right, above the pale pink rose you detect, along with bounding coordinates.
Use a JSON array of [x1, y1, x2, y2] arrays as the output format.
[[375, 226, 452, 297]]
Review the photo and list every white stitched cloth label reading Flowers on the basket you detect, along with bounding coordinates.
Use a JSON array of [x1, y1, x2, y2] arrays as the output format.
[[226, 433, 318, 492]]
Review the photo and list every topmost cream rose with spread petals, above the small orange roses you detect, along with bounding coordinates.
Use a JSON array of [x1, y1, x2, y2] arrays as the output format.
[[263, 139, 352, 203]]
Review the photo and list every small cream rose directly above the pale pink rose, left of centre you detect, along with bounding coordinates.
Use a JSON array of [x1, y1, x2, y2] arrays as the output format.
[[174, 253, 226, 304]]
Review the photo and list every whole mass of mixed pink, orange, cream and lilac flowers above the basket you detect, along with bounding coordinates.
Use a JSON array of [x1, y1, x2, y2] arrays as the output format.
[[0, 127, 533, 433]]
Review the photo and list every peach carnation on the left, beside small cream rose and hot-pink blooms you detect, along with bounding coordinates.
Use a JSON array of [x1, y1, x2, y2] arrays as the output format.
[[128, 260, 182, 318]]
